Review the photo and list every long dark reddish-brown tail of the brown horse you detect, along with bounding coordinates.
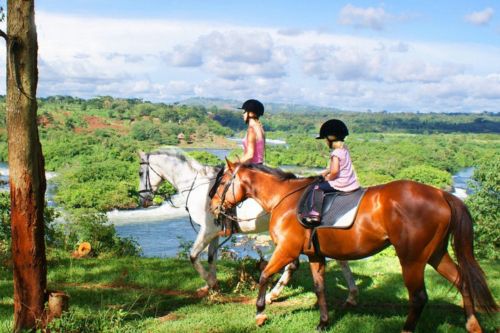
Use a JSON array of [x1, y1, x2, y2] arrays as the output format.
[[445, 193, 498, 314]]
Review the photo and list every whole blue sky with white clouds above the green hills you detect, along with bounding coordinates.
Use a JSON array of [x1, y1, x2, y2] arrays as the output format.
[[0, 0, 500, 112]]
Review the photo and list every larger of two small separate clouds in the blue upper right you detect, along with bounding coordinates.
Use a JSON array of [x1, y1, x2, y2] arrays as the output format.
[[338, 4, 392, 30]]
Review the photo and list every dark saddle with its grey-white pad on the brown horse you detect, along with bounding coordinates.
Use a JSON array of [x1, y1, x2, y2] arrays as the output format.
[[297, 184, 366, 229]]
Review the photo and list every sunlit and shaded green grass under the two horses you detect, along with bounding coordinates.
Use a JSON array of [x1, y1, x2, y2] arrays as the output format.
[[0, 256, 500, 333]]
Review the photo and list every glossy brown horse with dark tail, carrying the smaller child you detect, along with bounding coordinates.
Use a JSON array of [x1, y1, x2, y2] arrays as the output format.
[[211, 162, 498, 332]]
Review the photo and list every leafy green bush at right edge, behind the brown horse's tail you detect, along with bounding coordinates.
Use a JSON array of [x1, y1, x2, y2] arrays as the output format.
[[466, 155, 500, 260]]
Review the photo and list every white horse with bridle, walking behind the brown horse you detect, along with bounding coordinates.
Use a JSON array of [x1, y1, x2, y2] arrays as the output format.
[[139, 149, 358, 306]]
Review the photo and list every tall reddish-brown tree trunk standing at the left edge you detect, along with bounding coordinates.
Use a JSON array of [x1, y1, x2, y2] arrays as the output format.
[[7, 0, 47, 332]]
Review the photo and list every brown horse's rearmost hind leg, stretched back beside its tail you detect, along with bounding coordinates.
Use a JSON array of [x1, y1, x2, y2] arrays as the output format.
[[429, 252, 482, 333]]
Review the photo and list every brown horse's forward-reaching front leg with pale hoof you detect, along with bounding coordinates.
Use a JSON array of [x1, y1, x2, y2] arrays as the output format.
[[255, 246, 297, 326]]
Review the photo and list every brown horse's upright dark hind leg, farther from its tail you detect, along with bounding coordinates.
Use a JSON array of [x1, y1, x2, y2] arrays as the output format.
[[402, 262, 428, 332]]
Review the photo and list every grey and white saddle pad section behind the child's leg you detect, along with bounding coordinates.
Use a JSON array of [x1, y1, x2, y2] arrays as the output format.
[[320, 188, 366, 228]]
